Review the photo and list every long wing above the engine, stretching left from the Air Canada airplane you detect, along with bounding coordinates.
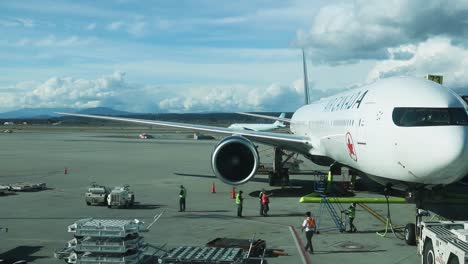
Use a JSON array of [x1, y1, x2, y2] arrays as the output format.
[[57, 113, 313, 154]]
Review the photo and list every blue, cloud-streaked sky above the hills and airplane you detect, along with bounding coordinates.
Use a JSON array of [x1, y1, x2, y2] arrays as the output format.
[[0, 0, 468, 113]]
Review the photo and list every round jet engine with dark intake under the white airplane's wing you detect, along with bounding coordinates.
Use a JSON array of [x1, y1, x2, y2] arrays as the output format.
[[211, 136, 260, 185]]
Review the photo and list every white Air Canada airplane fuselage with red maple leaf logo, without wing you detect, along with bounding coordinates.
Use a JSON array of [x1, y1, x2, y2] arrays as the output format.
[[291, 77, 468, 186]]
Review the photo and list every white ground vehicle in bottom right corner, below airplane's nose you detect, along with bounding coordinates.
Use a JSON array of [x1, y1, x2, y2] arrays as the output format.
[[417, 221, 468, 264]]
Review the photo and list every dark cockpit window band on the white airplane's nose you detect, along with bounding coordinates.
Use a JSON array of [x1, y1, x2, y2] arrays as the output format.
[[392, 107, 468, 127]]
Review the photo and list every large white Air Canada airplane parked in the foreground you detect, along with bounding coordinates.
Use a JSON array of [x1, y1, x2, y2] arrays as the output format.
[[58, 52, 468, 194]]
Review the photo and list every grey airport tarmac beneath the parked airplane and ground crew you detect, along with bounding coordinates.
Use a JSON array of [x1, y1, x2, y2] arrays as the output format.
[[0, 126, 432, 264]]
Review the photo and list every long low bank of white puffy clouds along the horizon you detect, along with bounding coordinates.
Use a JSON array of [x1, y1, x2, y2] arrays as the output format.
[[0, 72, 336, 112]]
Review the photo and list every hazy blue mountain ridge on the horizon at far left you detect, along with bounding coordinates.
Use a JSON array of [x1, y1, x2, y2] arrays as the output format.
[[0, 107, 135, 119]]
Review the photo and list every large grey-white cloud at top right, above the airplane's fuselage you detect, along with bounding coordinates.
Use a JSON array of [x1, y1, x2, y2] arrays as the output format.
[[295, 0, 468, 64]]
